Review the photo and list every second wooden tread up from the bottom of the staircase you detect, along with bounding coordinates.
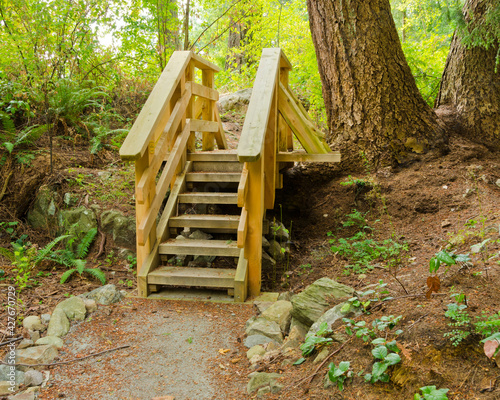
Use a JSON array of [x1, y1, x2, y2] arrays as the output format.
[[159, 239, 240, 257]]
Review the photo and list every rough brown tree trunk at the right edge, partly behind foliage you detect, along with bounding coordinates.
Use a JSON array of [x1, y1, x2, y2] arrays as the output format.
[[436, 0, 500, 149]]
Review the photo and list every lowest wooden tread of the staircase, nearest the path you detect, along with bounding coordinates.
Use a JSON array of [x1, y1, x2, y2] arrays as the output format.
[[148, 266, 236, 288]]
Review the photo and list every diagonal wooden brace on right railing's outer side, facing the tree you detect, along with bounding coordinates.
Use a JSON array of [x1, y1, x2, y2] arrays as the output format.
[[278, 83, 329, 154]]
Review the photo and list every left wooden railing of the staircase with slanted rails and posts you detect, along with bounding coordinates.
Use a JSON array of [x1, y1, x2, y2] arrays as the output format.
[[120, 51, 227, 296]]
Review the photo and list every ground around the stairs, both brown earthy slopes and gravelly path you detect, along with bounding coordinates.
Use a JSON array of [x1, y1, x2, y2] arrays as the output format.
[[0, 119, 500, 400]]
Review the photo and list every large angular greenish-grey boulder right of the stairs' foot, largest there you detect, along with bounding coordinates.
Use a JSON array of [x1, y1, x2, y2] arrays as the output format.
[[291, 278, 354, 327]]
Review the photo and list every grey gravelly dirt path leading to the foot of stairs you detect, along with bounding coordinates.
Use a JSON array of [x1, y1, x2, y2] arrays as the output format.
[[39, 299, 253, 400]]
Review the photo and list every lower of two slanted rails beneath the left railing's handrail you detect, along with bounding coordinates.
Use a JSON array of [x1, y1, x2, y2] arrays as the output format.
[[137, 122, 190, 244]]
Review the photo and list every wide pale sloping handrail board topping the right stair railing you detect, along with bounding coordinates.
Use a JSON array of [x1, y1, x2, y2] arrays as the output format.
[[238, 49, 281, 162]]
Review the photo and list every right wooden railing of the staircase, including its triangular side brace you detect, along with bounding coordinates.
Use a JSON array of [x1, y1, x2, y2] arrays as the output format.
[[238, 48, 340, 297]]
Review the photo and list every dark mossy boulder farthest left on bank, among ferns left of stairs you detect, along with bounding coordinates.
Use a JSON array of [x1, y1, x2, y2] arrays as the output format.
[[28, 185, 58, 231]]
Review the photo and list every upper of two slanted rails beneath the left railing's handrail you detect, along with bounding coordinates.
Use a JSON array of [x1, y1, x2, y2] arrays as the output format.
[[136, 89, 191, 204]]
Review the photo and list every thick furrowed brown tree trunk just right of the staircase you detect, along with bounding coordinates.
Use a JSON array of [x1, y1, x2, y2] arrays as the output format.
[[307, 0, 445, 167]]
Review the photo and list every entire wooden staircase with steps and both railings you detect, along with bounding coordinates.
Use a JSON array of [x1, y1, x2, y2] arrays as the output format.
[[120, 49, 340, 302]]
